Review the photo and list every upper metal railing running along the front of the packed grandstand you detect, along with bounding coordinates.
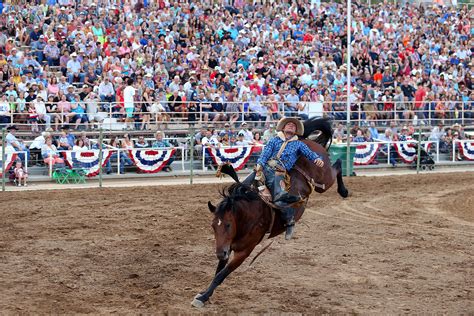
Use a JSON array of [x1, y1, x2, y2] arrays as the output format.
[[0, 100, 474, 132]]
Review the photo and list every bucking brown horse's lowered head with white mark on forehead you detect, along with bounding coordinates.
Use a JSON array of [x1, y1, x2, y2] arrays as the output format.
[[207, 201, 237, 260]]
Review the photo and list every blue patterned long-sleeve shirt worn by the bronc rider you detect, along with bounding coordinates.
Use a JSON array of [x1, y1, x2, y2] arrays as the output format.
[[257, 136, 321, 170]]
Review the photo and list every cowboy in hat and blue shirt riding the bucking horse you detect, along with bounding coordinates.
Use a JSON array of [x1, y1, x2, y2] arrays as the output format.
[[255, 117, 324, 240]]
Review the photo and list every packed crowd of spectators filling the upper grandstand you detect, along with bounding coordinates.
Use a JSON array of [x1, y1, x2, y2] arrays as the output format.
[[0, 0, 474, 132]]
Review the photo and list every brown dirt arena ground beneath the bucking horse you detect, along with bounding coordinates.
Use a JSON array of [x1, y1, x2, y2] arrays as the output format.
[[0, 173, 474, 315]]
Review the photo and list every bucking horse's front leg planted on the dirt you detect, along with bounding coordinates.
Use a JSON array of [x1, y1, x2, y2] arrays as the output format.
[[191, 247, 255, 307]]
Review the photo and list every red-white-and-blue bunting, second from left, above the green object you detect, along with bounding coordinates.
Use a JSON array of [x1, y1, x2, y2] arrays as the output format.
[[63, 149, 112, 177]]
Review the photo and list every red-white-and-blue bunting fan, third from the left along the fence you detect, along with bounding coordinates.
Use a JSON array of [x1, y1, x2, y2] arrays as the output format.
[[128, 148, 176, 173]]
